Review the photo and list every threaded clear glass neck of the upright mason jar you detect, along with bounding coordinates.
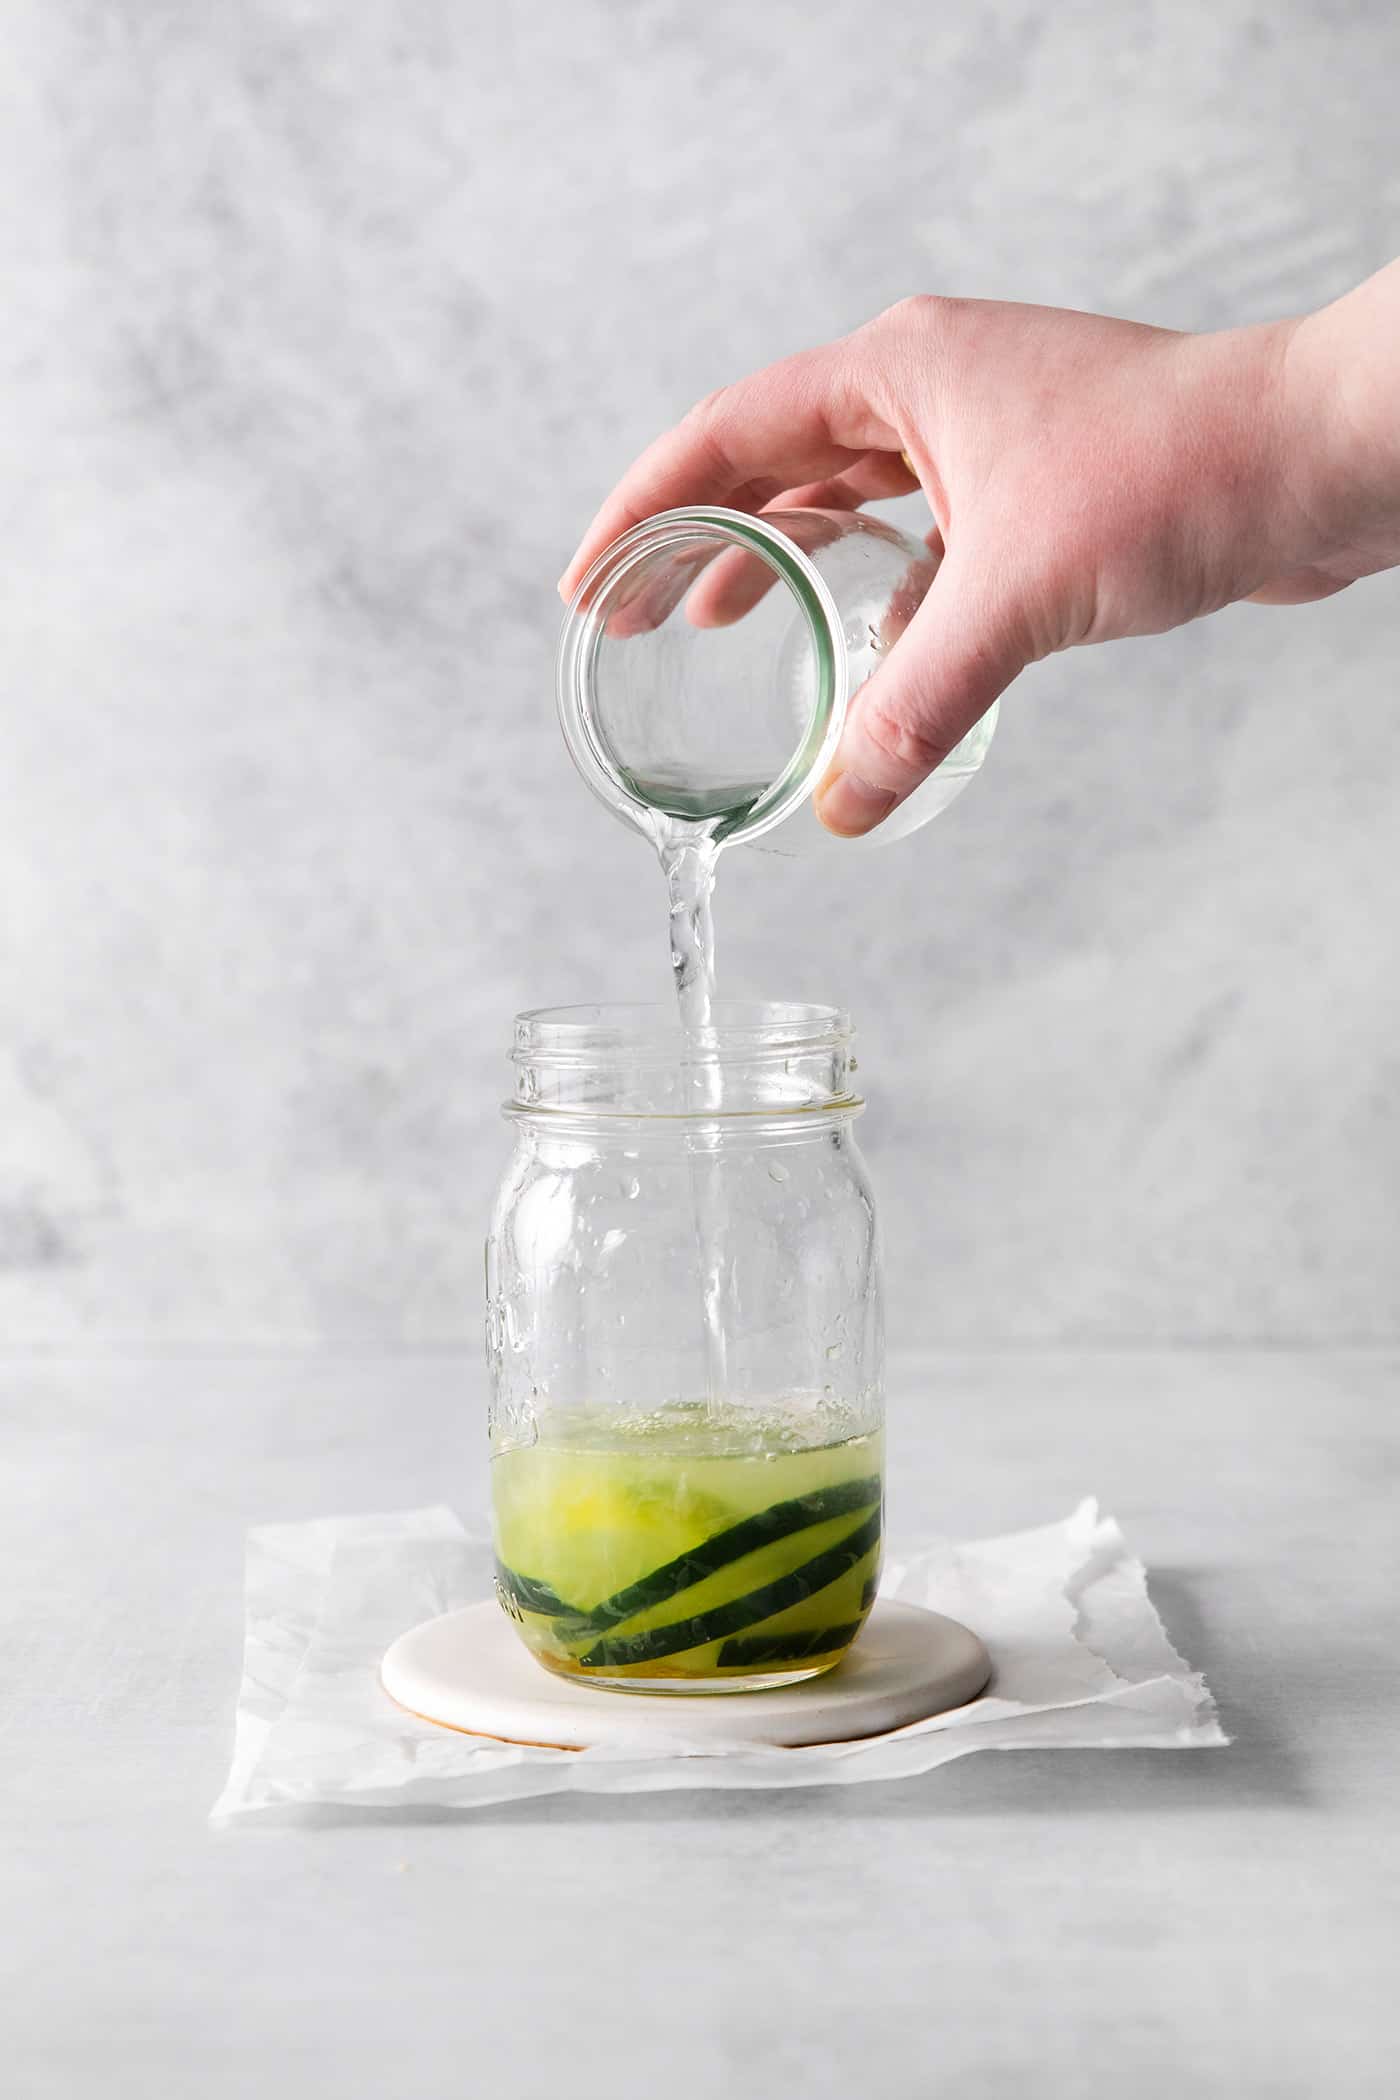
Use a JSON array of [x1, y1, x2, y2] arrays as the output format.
[[506, 1000, 861, 1121]]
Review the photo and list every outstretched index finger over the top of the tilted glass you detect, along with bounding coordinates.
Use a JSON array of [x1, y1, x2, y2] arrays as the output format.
[[558, 338, 900, 599]]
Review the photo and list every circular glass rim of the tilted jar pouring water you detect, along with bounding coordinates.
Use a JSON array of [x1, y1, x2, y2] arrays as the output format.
[[556, 504, 848, 842]]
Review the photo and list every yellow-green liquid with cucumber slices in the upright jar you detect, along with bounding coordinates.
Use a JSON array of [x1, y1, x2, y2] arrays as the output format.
[[491, 1403, 884, 1691]]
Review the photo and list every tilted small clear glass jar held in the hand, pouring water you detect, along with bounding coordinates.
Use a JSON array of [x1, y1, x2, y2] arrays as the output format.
[[558, 508, 997, 855]]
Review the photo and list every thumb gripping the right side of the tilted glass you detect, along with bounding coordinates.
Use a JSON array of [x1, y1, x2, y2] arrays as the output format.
[[816, 557, 1033, 838]]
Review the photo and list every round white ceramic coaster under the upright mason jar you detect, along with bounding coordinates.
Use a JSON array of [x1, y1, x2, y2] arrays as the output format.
[[380, 1598, 991, 1749]]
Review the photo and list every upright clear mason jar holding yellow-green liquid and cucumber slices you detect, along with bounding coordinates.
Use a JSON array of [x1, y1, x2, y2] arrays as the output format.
[[487, 1002, 884, 1693]]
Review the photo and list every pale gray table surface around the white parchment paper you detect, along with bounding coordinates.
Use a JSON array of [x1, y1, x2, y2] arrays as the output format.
[[0, 1350, 1400, 2100]]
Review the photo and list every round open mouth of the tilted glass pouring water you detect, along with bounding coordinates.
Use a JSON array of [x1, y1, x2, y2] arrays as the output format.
[[558, 504, 846, 842]]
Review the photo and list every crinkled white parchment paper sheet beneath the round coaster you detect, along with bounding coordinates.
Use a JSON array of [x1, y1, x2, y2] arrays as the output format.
[[212, 1502, 1226, 1823]]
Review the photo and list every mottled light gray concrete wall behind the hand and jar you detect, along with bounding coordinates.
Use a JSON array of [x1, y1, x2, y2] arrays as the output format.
[[0, 0, 1400, 1350]]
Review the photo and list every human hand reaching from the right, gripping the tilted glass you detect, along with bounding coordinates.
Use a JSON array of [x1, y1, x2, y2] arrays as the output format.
[[560, 265, 1400, 836]]
